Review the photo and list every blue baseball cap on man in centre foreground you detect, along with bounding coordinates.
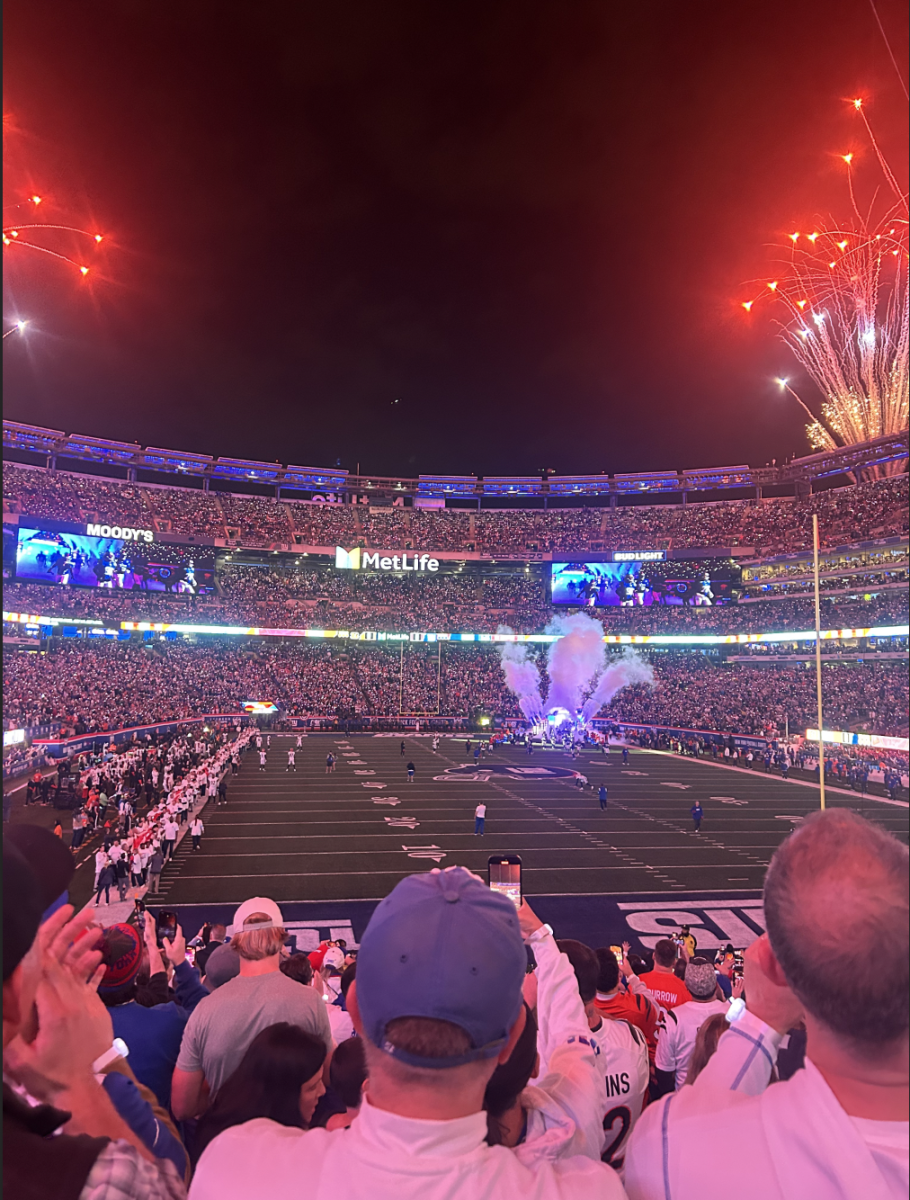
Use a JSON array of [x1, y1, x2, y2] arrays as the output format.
[[357, 866, 527, 1068]]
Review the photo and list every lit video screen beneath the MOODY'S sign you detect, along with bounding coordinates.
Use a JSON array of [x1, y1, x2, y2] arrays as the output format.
[[16, 526, 215, 595]]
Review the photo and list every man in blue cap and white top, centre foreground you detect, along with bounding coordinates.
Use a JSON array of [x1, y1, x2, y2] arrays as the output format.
[[190, 866, 623, 1200]]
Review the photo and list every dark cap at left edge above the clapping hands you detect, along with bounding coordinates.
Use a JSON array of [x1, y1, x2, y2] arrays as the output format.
[[4, 826, 74, 983]]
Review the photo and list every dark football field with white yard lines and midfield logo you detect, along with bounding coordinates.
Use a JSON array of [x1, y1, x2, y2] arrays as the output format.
[[153, 734, 908, 906]]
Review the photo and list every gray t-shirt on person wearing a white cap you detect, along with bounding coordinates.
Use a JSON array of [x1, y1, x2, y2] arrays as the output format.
[[176, 971, 333, 1093]]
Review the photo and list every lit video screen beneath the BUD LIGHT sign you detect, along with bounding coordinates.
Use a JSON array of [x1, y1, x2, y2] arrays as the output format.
[[551, 558, 740, 608]]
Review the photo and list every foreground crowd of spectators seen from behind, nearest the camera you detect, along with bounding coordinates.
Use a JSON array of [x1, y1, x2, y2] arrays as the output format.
[[4, 809, 910, 1200]]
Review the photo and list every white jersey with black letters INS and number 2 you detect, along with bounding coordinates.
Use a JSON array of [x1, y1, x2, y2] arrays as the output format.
[[591, 1016, 651, 1170]]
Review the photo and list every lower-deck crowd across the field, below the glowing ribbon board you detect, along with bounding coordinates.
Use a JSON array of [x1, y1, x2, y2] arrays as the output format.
[[4, 640, 908, 736]]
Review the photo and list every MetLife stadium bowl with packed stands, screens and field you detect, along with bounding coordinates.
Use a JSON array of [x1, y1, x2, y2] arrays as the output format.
[[4, 421, 908, 926]]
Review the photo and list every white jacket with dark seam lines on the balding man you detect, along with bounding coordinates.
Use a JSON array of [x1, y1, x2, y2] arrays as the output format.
[[625, 1012, 908, 1200]]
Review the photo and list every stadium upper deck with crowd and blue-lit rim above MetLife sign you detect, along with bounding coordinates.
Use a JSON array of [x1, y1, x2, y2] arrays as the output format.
[[4, 422, 908, 559]]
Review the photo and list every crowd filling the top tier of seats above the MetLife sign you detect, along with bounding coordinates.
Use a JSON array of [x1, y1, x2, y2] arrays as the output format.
[[4, 463, 909, 554]]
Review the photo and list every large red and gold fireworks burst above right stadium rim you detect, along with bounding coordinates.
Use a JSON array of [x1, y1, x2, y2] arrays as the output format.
[[742, 100, 910, 450]]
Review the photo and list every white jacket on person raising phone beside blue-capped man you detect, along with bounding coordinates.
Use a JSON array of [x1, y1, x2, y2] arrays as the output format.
[[515, 934, 612, 1171]]
